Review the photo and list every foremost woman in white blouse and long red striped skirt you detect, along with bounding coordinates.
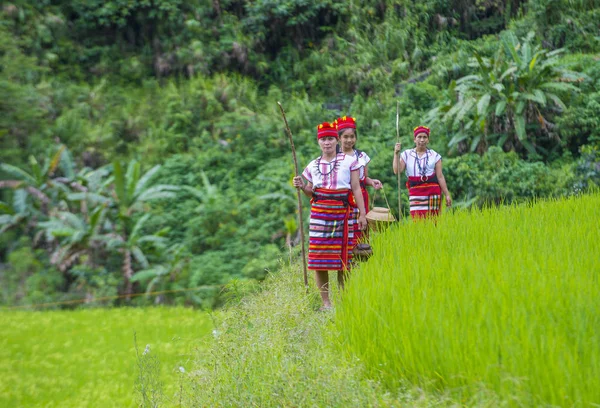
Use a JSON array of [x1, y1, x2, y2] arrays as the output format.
[[294, 122, 367, 310]]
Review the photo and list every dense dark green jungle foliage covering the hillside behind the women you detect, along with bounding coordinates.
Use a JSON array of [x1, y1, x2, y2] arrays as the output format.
[[0, 0, 600, 307]]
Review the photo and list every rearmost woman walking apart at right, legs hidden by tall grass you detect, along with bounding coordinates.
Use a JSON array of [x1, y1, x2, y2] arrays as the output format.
[[393, 126, 452, 218]]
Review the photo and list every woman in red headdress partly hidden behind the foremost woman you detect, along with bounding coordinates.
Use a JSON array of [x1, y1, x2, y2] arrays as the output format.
[[333, 116, 383, 242]]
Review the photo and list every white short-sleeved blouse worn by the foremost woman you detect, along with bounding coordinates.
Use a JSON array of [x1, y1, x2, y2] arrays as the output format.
[[302, 153, 362, 190]]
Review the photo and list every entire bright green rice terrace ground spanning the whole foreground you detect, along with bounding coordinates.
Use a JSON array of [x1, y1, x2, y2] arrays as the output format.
[[0, 193, 600, 407]]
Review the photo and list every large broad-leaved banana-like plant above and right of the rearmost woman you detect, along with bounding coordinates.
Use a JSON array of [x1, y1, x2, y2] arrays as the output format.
[[427, 31, 579, 157]]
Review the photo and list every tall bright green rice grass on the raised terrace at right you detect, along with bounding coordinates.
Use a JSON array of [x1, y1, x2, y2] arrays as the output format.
[[335, 194, 600, 406]]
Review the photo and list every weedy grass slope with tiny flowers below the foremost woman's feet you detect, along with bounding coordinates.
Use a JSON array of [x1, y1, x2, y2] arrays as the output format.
[[186, 265, 450, 407]]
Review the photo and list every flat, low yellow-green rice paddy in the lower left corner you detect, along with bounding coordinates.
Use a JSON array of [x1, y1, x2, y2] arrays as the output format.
[[0, 308, 212, 407]]
